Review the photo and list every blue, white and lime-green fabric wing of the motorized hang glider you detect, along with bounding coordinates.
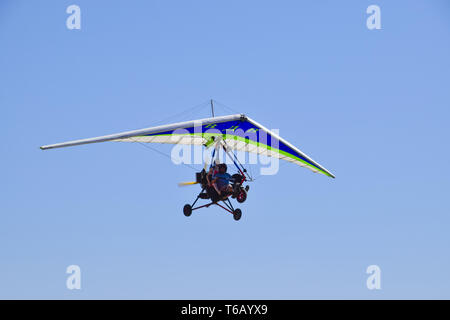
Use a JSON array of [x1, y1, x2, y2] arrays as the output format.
[[41, 114, 334, 178]]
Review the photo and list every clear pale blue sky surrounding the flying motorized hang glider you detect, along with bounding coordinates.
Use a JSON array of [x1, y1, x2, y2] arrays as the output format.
[[0, 0, 450, 299]]
